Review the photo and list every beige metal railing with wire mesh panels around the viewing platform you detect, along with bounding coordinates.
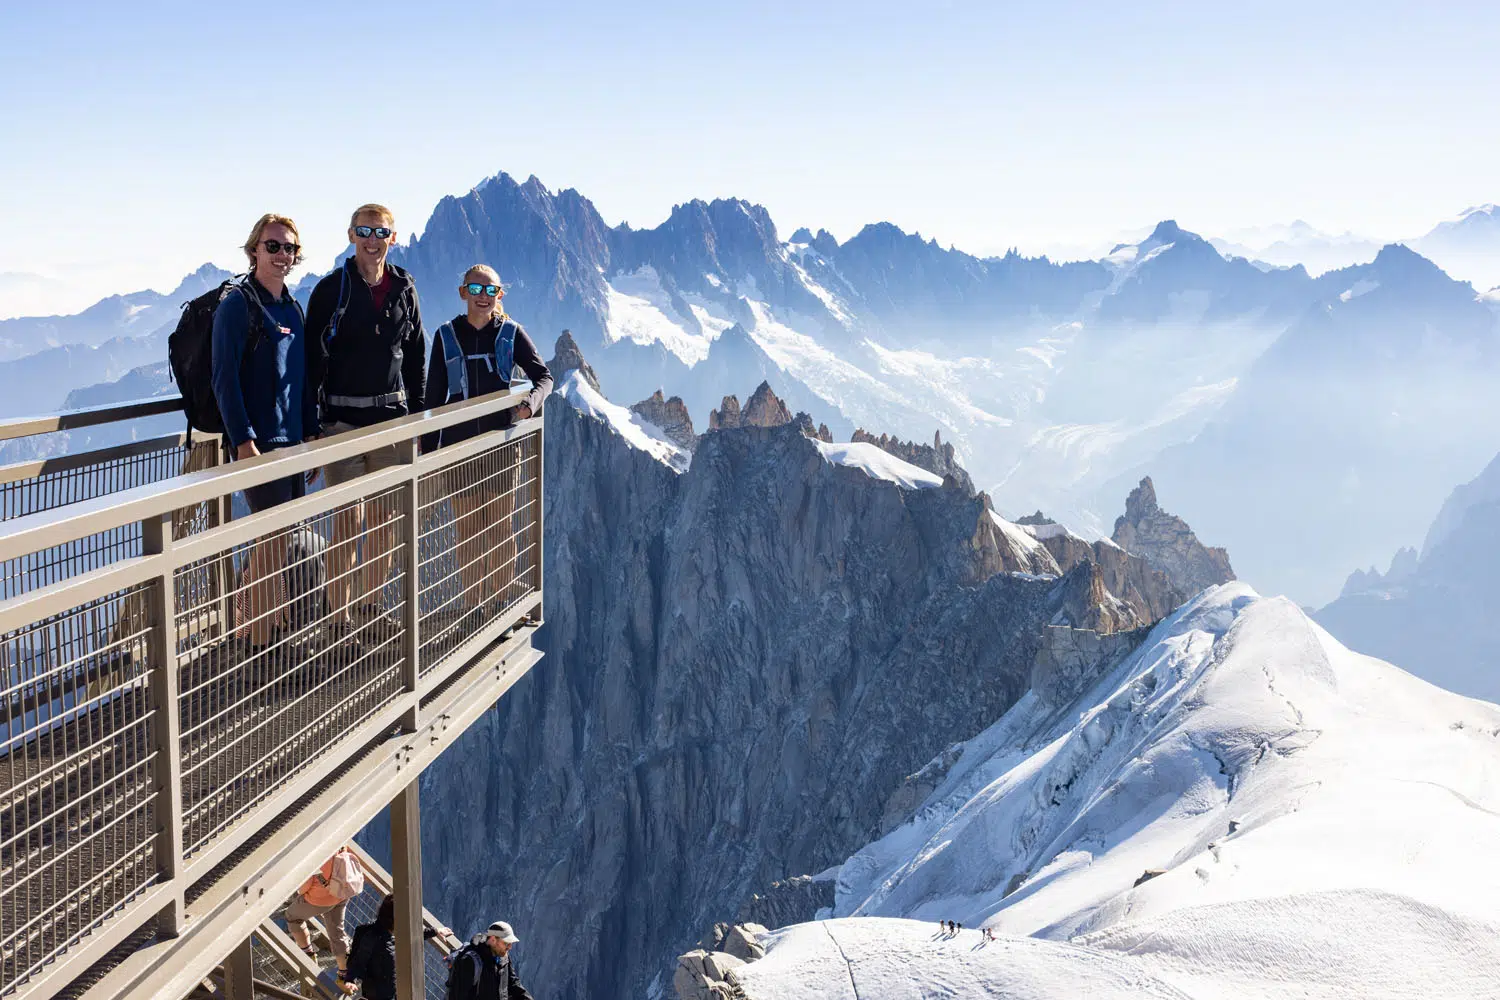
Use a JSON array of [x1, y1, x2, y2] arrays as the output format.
[[0, 394, 542, 996]]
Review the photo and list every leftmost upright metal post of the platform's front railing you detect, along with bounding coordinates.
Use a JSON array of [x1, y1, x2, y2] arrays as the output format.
[[141, 511, 188, 937]]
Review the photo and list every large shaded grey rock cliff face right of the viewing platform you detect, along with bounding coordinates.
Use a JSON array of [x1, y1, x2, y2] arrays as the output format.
[[402, 400, 1158, 1000]]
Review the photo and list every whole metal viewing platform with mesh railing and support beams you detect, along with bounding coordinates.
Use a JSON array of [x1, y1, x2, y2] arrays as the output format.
[[0, 391, 543, 1000]]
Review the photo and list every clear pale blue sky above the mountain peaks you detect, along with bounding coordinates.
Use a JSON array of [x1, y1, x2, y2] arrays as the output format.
[[0, 0, 1500, 305]]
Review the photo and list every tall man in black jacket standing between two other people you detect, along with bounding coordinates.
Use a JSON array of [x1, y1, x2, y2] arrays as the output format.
[[306, 204, 428, 642]]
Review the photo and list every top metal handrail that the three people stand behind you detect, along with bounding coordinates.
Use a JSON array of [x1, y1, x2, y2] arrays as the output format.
[[0, 391, 527, 561]]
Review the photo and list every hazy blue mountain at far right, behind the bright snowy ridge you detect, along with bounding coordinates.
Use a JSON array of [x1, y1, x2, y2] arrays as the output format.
[[1100, 244, 1500, 603]]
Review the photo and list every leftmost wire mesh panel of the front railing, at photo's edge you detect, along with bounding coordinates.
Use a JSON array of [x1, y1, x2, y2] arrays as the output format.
[[0, 585, 158, 993]]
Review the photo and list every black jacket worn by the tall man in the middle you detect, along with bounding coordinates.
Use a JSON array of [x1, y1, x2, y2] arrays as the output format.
[[303, 258, 428, 436]]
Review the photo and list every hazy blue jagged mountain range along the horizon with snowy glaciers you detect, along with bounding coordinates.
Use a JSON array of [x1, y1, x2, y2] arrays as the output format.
[[0, 174, 1500, 606]]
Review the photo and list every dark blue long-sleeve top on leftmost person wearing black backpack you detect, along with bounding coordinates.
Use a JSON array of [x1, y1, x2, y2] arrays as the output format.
[[213, 279, 309, 451]]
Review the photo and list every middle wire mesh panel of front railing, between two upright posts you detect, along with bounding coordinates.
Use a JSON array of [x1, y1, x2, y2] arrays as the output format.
[[176, 487, 407, 858]]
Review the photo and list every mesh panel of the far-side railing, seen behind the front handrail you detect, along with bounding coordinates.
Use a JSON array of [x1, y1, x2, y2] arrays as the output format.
[[0, 439, 219, 600]]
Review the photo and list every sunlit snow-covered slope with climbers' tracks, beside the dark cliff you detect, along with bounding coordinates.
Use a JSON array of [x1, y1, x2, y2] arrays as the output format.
[[746, 583, 1500, 1000]]
